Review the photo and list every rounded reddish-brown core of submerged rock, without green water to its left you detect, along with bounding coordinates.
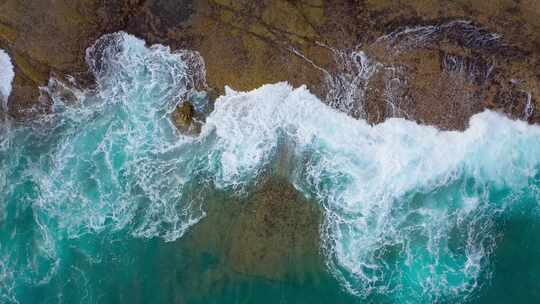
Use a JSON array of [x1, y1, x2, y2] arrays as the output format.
[[229, 181, 321, 280]]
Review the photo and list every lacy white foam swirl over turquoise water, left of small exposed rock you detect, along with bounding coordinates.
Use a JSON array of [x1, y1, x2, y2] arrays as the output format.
[[38, 33, 209, 241]]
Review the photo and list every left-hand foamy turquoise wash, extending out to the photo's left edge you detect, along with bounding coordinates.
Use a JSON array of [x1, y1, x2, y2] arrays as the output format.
[[0, 33, 206, 295]]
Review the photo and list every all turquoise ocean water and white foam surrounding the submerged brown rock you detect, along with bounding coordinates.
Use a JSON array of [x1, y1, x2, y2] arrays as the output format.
[[0, 33, 540, 303]]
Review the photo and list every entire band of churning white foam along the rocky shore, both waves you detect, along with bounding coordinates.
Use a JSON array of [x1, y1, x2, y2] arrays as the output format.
[[0, 33, 540, 303]]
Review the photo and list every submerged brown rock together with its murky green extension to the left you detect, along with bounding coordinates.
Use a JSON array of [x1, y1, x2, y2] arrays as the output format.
[[179, 178, 324, 282]]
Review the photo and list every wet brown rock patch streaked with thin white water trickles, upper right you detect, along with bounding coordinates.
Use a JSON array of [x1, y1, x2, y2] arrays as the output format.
[[338, 20, 540, 130]]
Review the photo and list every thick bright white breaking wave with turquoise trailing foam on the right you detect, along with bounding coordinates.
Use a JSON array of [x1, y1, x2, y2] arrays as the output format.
[[206, 83, 540, 301]]
